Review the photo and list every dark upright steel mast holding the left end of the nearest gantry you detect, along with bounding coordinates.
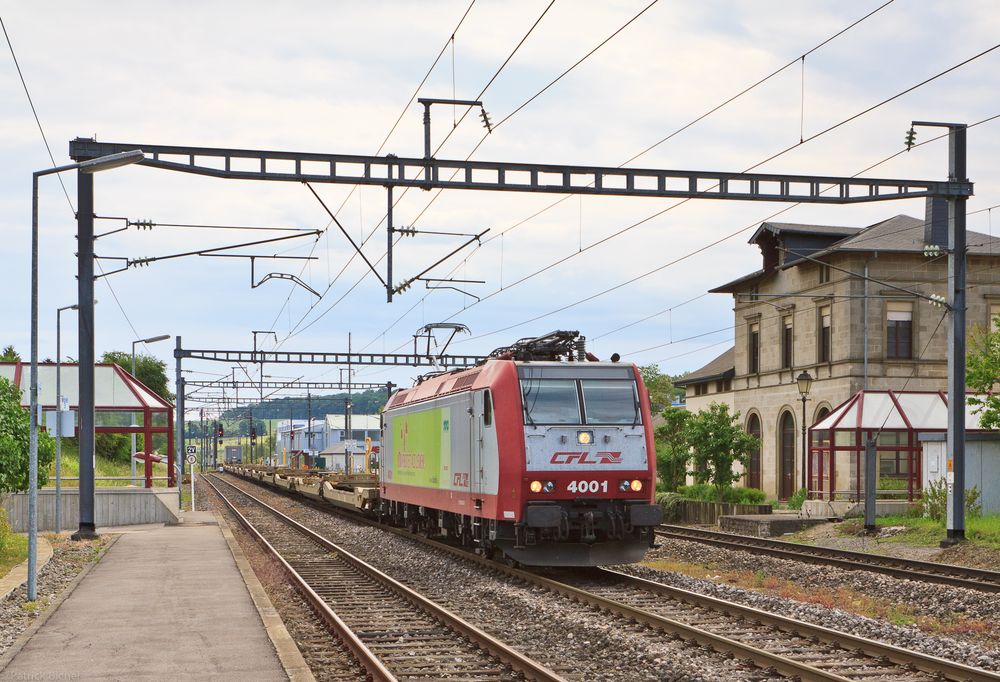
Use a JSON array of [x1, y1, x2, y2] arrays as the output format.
[[73, 171, 97, 540]]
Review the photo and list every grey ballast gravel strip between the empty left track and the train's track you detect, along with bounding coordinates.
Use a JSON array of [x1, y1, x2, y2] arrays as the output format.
[[217, 476, 781, 682]]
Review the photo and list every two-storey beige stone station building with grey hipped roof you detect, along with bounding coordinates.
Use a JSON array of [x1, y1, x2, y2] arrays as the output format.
[[676, 209, 1000, 499]]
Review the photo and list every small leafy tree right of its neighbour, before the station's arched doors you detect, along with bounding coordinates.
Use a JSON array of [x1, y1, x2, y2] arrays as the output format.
[[684, 403, 759, 499]]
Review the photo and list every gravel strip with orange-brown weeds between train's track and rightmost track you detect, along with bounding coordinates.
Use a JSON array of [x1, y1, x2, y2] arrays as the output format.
[[640, 538, 1000, 670]]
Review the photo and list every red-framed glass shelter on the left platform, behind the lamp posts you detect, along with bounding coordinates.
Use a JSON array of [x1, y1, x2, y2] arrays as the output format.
[[0, 362, 176, 488]]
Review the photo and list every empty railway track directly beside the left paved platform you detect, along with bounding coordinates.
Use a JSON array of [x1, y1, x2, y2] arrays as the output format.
[[202, 475, 563, 682]]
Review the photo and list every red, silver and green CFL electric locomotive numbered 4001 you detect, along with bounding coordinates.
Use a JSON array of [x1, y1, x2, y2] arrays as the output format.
[[378, 331, 662, 566]]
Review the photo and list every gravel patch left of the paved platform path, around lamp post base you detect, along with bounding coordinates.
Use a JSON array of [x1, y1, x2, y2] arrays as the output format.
[[0, 534, 111, 658]]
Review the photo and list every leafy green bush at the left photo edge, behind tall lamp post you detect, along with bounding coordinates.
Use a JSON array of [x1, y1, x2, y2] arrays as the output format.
[[0, 378, 56, 497]]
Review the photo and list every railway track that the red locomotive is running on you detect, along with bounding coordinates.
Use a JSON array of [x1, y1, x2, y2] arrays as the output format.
[[217, 472, 1000, 682]]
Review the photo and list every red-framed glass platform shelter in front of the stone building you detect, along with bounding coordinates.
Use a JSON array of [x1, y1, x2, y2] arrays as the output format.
[[806, 390, 984, 502]]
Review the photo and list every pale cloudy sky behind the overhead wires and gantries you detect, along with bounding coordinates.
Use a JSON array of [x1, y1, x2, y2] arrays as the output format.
[[0, 0, 1000, 418]]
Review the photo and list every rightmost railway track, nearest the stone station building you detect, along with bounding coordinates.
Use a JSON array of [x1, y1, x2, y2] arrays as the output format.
[[656, 525, 1000, 592]]
